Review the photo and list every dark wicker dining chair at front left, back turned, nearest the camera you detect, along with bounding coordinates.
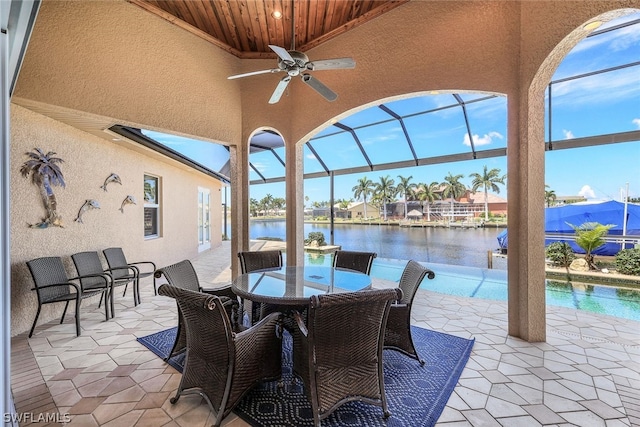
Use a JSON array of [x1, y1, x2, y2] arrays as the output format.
[[158, 285, 282, 426]]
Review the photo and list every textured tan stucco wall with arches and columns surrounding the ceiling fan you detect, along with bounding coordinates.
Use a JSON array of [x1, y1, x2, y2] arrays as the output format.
[[14, 0, 640, 340]]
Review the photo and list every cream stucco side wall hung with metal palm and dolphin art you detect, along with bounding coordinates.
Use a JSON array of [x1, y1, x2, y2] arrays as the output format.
[[10, 104, 222, 335]]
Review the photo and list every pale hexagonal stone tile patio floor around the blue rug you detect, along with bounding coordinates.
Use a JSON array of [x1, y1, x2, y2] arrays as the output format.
[[11, 242, 640, 427]]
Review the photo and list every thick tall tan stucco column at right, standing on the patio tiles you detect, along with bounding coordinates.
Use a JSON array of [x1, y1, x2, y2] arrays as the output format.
[[507, 90, 546, 342]]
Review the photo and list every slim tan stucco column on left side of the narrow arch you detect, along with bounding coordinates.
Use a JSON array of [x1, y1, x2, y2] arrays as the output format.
[[229, 143, 249, 278]]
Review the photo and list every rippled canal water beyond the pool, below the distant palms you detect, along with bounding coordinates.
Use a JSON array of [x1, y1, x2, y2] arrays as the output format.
[[249, 221, 507, 270]]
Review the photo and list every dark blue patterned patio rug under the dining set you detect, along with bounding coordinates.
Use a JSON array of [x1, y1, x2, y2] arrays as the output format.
[[138, 326, 475, 427]]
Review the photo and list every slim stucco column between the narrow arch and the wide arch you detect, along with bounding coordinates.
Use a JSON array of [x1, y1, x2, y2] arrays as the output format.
[[285, 143, 304, 266]]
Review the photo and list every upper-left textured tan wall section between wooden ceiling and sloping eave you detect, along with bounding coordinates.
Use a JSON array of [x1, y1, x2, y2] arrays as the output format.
[[14, 0, 242, 144]]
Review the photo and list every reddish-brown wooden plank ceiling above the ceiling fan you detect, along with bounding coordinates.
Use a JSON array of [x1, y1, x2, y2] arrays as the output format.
[[128, 0, 409, 58]]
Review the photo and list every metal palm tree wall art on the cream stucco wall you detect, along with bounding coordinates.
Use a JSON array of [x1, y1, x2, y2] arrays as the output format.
[[20, 148, 65, 228]]
